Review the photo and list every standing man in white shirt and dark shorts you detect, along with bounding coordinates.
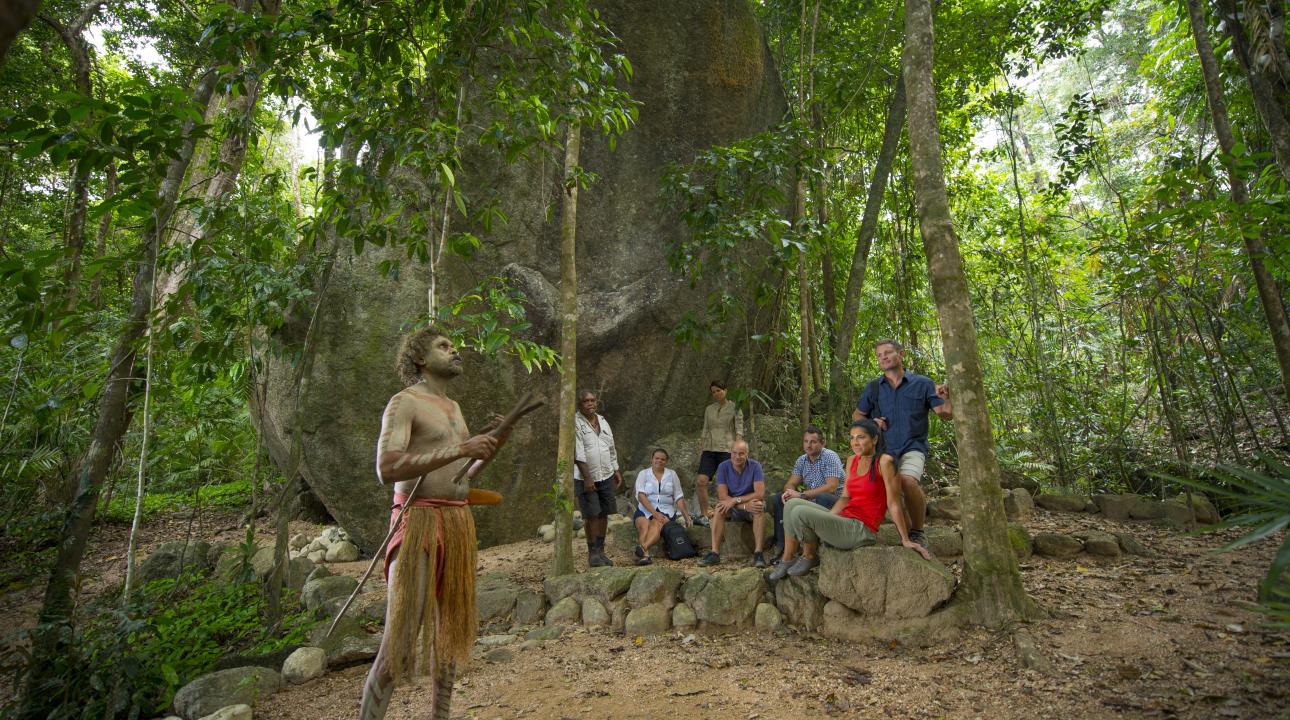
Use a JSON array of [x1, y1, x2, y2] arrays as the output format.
[[573, 390, 623, 568]]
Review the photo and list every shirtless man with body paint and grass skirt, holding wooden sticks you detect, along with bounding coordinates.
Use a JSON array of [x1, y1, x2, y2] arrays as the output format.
[[359, 328, 504, 720]]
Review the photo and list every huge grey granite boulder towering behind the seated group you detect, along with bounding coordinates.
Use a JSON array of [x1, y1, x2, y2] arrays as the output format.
[[252, 0, 786, 552]]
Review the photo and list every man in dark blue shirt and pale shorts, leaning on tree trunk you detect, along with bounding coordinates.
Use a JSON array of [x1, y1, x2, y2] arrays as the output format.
[[851, 339, 953, 547]]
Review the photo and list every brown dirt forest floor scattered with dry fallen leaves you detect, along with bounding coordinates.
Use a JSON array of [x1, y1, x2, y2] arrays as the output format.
[[0, 510, 1290, 720]]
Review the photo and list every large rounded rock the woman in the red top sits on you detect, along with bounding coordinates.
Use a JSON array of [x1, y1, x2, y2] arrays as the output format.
[[819, 546, 955, 618]]
